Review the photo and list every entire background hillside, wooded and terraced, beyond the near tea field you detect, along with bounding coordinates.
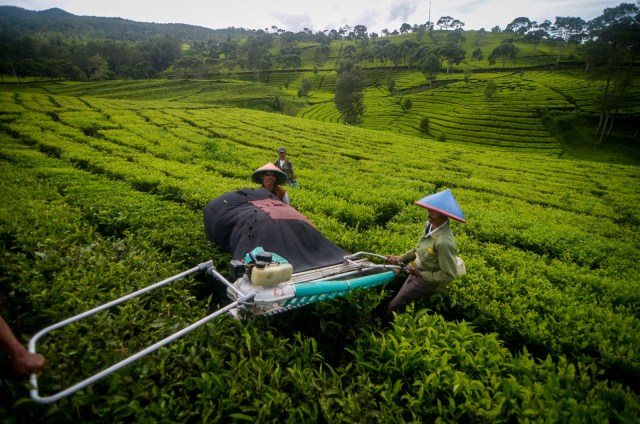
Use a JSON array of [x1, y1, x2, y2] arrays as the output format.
[[0, 6, 640, 163]]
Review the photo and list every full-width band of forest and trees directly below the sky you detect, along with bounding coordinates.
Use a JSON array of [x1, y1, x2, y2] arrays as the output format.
[[0, 3, 640, 81]]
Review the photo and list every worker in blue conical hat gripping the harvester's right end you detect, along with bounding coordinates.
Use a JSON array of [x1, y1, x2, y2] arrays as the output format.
[[384, 190, 466, 321]]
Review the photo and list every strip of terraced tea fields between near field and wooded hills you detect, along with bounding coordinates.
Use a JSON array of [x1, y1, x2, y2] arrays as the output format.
[[4, 70, 640, 164]]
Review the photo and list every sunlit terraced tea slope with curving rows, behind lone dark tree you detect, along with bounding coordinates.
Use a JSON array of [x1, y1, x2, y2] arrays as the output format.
[[298, 71, 640, 156]]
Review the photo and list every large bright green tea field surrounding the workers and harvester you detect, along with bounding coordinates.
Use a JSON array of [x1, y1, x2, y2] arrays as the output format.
[[0, 82, 640, 423]]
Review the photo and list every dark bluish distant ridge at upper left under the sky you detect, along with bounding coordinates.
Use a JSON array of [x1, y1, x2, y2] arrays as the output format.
[[0, 6, 254, 42]]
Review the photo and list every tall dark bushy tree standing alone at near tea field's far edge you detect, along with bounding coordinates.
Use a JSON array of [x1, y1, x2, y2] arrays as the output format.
[[334, 60, 366, 125]]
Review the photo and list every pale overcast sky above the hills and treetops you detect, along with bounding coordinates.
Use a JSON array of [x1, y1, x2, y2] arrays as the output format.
[[0, 0, 636, 34]]
